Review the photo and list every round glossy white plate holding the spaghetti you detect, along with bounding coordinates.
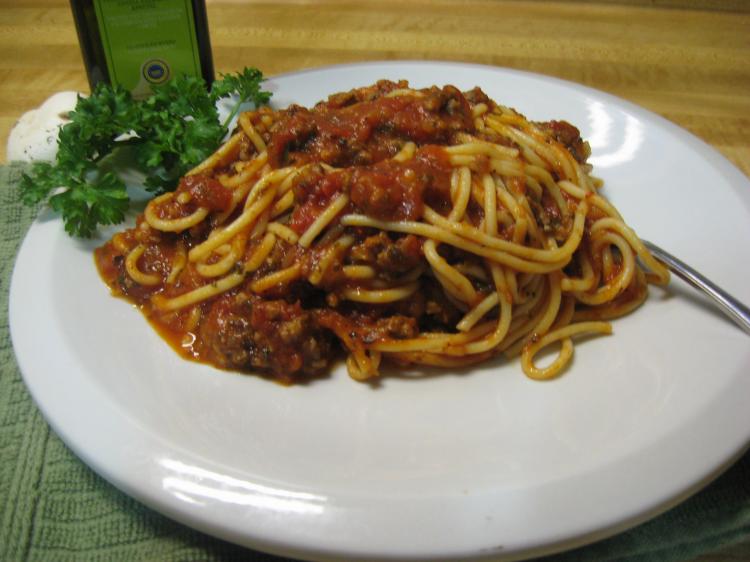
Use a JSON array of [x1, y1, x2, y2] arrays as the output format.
[[10, 62, 750, 559]]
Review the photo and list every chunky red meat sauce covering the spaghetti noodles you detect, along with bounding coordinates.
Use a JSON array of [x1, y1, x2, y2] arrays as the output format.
[[95, 81, 584, 383]]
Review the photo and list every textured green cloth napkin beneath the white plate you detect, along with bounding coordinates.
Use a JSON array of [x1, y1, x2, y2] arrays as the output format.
[[0, 159, 750, 562]]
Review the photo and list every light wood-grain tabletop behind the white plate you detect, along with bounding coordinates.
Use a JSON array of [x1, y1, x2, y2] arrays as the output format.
[[0, 0, 750, 562]]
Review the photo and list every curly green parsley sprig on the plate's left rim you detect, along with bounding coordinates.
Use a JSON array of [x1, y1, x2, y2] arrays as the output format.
[[20, 68, 271, 238]]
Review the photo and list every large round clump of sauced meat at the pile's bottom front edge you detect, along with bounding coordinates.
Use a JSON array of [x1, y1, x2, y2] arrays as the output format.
[[199, 296, 332, 380]]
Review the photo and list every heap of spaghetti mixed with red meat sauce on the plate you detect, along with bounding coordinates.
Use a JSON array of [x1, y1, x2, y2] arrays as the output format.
[[96, 81, 669, 383]]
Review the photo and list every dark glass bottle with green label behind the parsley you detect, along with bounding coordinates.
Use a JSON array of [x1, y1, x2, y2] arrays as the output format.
[[70, 0, 214, 99]]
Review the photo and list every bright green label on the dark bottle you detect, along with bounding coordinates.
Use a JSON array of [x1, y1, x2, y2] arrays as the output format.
[[94, 0, 201, 98]]
